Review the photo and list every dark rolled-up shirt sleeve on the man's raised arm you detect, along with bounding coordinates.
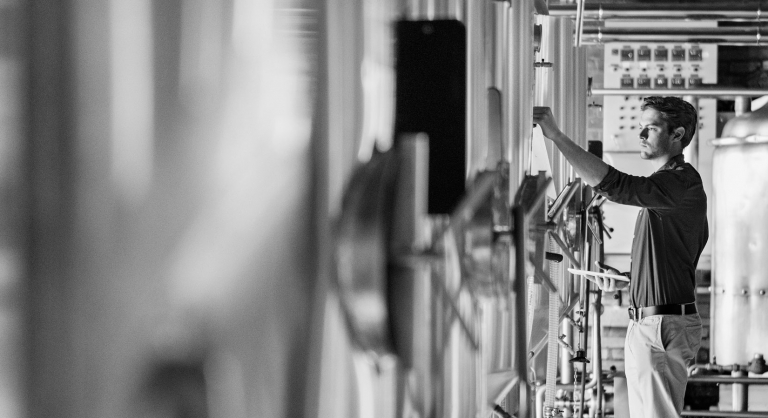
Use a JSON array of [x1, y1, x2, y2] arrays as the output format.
[[595, 166, 688, 209]]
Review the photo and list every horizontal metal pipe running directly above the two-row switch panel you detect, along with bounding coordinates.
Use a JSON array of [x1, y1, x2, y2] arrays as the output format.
[[582, 26, 768, 45]]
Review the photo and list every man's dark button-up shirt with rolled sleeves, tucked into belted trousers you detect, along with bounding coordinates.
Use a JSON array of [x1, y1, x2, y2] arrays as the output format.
[[595, 154, 709, 307]]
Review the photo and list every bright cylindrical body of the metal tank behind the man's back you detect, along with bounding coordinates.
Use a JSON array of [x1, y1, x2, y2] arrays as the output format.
[[710, 140, 768, 364]]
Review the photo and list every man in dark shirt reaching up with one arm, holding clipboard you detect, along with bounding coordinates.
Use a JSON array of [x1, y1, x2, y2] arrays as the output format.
[[533, 97, 709, 418]]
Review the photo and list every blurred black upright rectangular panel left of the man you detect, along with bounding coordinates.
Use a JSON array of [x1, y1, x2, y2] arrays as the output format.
[[395, 20, 467, 214]]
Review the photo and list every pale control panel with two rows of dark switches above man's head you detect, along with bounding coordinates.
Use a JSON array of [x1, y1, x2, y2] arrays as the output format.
[[603, 43, 717, 89]]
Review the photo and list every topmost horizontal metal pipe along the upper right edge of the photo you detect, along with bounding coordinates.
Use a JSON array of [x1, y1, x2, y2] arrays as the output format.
[[549, 2, 761, 22]]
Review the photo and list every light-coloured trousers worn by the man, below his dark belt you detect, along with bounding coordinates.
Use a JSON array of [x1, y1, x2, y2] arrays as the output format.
[[624, 314, 701, 418]]
